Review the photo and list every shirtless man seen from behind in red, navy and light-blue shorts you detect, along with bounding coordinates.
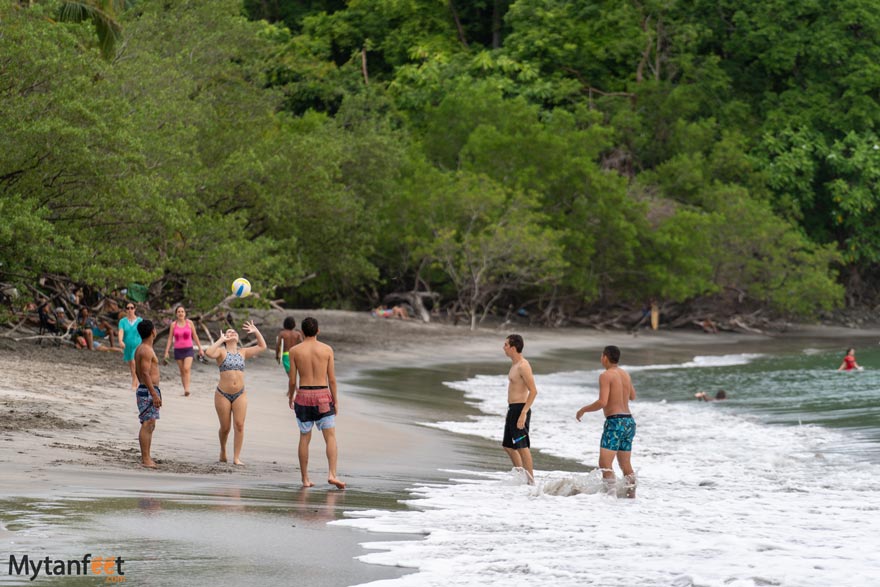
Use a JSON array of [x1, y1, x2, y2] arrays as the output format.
[[287, 318, 345, 489]]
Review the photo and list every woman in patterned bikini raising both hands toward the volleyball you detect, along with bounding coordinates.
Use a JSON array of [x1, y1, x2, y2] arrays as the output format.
[[205, 322, 266, 465]]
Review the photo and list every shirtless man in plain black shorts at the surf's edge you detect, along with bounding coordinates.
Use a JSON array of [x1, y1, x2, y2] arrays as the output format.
[[501, 334, 538, 485]]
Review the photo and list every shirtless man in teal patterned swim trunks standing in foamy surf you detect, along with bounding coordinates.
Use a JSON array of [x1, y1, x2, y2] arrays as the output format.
[[576, 346, 636, 497]]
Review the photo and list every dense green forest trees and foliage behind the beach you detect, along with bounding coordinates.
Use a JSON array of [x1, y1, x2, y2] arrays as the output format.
[[0, 0, 880, 323]]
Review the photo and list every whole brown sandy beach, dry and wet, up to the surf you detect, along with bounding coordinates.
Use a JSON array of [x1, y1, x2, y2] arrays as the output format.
[[0, 311, 868, 585]]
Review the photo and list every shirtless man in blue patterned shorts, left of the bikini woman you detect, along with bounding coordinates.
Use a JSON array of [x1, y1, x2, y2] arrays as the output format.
[[134, 320, 162, 469]]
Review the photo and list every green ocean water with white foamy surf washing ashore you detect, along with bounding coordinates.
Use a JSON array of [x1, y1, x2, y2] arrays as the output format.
[[332, 348, 880, 587]]
